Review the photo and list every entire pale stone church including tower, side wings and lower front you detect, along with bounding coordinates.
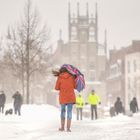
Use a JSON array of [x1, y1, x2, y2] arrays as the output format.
[[51, 3, 106, 104]]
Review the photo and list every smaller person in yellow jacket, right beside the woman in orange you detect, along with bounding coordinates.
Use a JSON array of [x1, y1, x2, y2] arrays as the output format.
[[76, 94, 84, 120]]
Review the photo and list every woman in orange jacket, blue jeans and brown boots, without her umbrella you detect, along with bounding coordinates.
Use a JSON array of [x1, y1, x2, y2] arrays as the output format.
[[53, 68, 76, 132]]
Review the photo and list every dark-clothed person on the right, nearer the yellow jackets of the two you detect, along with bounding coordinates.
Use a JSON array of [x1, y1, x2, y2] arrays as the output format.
[[114, 97, 123, 115]]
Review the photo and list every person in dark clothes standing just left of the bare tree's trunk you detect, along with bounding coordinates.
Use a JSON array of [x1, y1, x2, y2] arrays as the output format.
[[12, 91, 22, 116]]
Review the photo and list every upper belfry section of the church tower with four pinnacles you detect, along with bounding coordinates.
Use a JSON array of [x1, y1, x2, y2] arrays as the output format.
[[68, 3, 98, 42]]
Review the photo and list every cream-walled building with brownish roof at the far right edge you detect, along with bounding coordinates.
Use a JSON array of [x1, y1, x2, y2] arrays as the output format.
[[125, 41, 140, 110]]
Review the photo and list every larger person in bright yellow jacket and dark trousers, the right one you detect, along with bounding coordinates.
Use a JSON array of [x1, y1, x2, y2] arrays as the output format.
[[88, 90, 101, 120]]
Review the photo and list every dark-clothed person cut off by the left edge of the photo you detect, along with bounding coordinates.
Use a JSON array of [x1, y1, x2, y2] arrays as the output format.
[[0, 91, 6, 113]]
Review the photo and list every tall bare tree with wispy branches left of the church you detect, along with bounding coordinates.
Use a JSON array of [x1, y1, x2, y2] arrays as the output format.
[[7, 0, 50, 104]]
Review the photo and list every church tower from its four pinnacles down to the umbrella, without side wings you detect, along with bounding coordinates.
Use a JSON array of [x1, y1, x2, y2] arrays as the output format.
[[68, 3, 98, 80]]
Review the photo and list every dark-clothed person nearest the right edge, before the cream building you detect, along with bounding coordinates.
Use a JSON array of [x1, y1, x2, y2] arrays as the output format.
[[130, 97, 139, 113]]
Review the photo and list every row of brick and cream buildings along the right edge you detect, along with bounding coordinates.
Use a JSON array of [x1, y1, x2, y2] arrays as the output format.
[[106, 41, 140, 110]]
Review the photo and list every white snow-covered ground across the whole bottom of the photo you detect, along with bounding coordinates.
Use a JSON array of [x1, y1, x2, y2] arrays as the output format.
[[0, 105, 140, 140]]
